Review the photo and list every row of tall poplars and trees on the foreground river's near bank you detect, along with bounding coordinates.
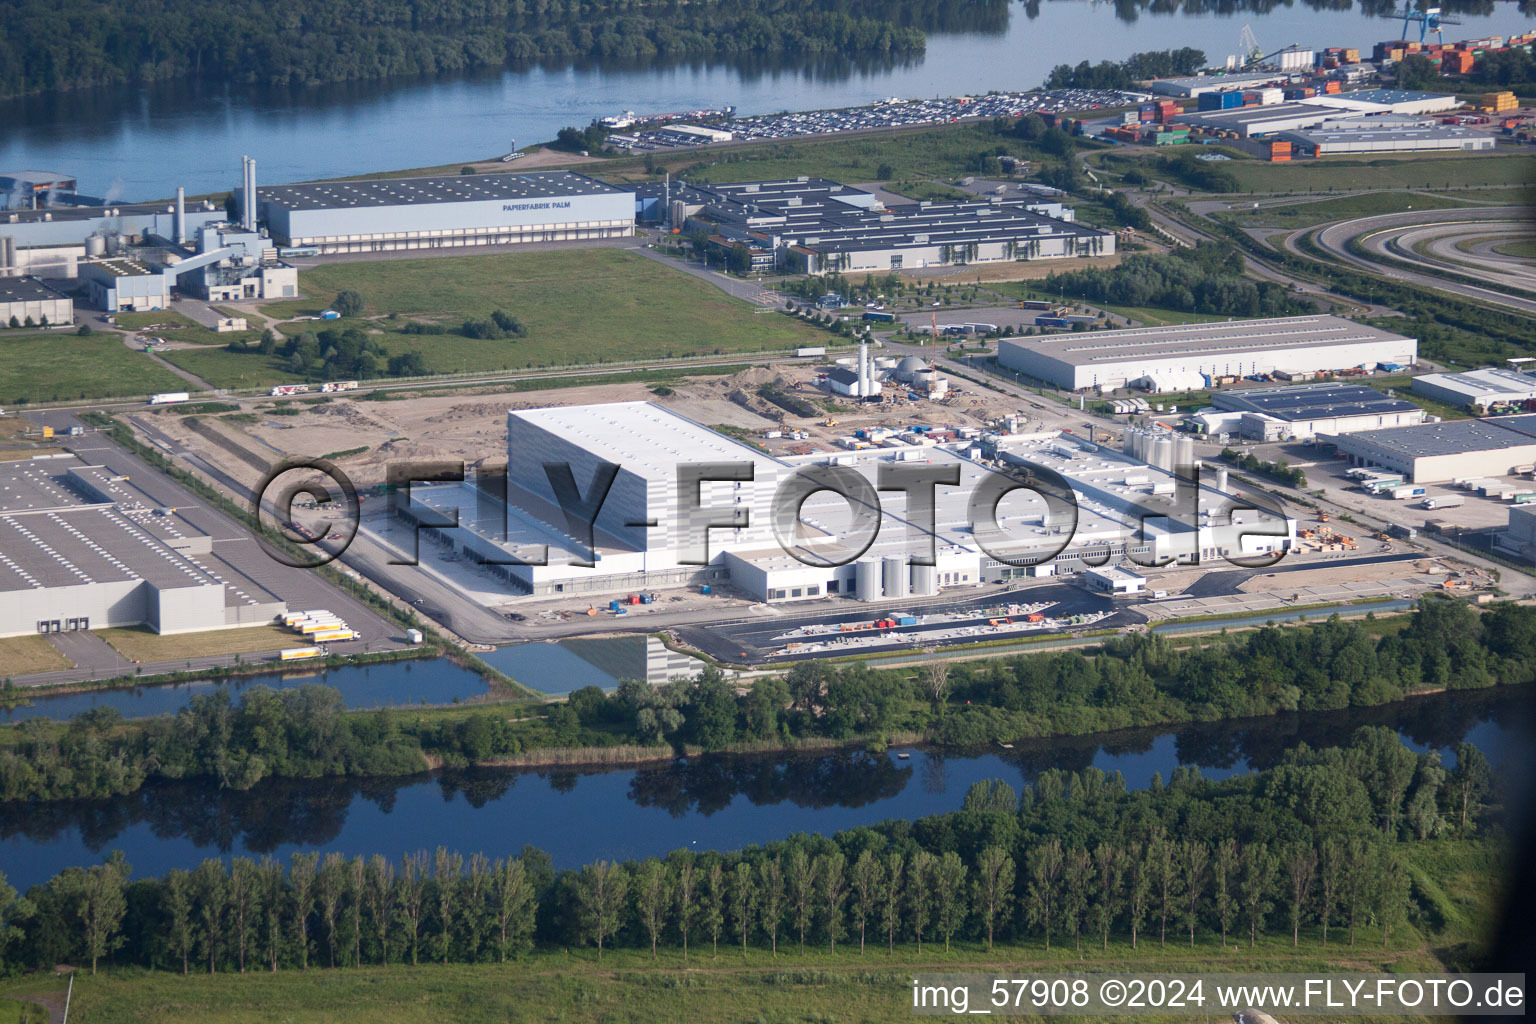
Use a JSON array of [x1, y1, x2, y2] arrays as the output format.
[[0, 728, 1493, 973]]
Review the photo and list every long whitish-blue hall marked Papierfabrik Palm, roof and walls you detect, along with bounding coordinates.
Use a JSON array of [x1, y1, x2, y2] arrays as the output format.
[[255, 170, 634, 253]]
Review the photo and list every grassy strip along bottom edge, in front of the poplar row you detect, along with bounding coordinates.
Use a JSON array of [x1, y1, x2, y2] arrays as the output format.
[[0, 840, 1502, 1024]]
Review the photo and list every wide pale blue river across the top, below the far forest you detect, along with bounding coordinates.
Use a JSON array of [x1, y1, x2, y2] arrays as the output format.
[[0, 0, 1530, 201]]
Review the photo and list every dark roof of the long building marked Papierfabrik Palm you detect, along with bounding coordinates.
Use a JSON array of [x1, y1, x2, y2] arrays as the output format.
[[257, 170, 624, 210]]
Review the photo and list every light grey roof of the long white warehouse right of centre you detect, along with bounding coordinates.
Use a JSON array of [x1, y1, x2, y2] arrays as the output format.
[[1003, 315, 1402, 373]]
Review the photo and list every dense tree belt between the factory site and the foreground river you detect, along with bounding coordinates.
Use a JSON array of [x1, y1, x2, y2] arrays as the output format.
[[0, 597, 1536, 801]]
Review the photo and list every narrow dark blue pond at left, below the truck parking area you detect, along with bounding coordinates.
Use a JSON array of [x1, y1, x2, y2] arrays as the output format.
[[0, 659, 488, 722]]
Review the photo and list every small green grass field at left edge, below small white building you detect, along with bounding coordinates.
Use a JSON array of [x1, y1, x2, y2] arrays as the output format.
[[0, 333, 186, 405]]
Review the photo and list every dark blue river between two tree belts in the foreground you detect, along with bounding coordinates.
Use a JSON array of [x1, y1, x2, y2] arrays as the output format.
[[0, 686, 1533, 890]]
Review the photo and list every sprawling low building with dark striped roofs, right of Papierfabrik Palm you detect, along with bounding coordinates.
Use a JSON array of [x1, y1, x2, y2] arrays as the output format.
[[687, 177, 1115, 273]]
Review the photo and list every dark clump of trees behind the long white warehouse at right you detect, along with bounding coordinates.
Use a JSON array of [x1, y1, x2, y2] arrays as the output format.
[[1041, 243, 1316, 316]]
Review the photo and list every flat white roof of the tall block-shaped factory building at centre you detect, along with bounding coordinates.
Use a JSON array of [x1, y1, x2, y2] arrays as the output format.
[[508, 402, 777, 485]]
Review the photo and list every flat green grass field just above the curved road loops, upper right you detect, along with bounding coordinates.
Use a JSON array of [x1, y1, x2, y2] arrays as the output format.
[[1221, 152, 1536, 196]]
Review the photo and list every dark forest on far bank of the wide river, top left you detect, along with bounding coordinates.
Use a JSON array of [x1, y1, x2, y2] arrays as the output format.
[[0, 0, 931, 97]]
